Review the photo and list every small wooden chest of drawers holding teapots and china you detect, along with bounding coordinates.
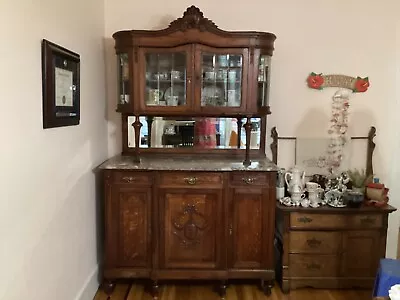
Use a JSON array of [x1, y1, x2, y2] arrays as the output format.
[[275, 204, 395, 292]]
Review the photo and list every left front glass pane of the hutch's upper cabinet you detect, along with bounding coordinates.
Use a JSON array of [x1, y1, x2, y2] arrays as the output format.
[[143, 49, 189, 109]]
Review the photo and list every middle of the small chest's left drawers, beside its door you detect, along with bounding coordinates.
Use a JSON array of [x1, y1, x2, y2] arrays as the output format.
[[289, 231, 342, 254]]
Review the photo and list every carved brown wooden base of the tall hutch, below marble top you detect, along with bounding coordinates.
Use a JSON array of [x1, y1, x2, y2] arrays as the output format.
[[100, 163, 275, 296]]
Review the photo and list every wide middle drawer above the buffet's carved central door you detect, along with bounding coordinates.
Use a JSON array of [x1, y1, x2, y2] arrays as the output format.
[[160, 172, 223, 187]]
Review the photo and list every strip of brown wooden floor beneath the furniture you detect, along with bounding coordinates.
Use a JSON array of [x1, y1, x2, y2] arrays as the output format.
[[94, 283, 372, 300]]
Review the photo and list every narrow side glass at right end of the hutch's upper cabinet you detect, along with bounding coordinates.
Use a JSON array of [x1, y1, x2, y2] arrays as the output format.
[[257, 55, 271, 107]]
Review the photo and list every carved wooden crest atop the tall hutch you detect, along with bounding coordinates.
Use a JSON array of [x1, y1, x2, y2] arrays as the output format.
[[169, 5, 218, 31]]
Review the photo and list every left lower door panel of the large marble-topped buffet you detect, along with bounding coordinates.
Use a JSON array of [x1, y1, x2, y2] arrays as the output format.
[[106, 185, 151, 267]]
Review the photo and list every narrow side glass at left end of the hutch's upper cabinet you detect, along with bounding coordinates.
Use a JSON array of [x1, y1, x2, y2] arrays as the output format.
[[117, 53, 131, 105]]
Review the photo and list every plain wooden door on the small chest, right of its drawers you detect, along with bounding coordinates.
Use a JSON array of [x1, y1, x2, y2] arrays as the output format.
[[341, 231, 381, 277]]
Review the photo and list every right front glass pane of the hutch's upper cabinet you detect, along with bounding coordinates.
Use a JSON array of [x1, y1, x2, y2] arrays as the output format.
[[200, 51, 244, 108]]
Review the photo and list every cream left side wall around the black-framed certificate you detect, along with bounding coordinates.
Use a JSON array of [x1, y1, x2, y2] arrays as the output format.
[[0, 0, 107, 300]]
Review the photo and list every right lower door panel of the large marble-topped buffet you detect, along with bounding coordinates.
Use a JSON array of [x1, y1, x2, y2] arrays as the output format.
[[229, 188, 268, 268]]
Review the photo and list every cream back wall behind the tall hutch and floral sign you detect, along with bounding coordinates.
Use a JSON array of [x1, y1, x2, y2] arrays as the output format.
[[105, 0, 400, 256]]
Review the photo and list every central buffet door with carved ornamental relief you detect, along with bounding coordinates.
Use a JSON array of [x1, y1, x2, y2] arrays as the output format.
[[160, 189, 222, 269]]
